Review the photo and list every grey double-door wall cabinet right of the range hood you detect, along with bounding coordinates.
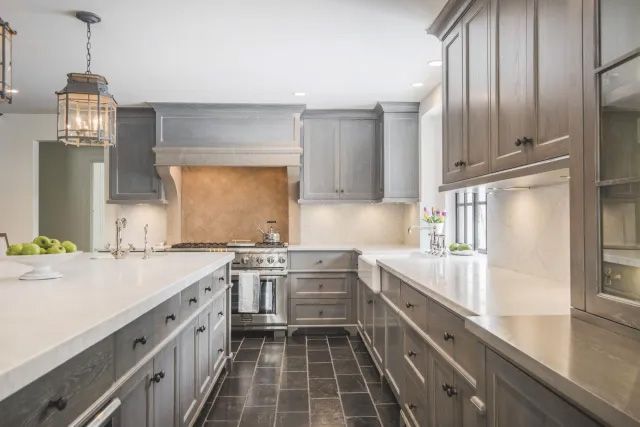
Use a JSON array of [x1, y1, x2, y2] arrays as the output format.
[[301, 111, 377, 201]]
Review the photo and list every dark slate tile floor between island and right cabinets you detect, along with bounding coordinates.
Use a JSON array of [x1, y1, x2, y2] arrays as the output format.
[[196, 335, 400, 427]]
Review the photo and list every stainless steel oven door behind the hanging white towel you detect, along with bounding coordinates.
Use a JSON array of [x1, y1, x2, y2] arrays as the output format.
[[231, 272, 287, 330]]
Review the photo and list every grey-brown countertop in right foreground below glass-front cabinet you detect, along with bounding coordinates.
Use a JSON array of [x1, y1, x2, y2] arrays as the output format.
[[465, 315, 640, 426]]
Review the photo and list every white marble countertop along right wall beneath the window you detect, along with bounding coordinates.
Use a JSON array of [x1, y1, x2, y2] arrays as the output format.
[[377, 254, 571, 316]]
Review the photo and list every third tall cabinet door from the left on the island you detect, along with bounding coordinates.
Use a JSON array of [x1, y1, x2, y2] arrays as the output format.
[[178, 319, 198, 426]]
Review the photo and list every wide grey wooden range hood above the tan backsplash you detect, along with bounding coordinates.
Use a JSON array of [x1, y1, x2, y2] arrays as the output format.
[[149, 103, 305, 166]]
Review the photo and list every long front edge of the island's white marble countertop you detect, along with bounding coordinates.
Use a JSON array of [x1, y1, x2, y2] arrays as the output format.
[[0, 253, 234, 401]]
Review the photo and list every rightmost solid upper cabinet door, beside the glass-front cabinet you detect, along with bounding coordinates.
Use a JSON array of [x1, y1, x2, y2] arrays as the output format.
[[527, 0, 582, 163]]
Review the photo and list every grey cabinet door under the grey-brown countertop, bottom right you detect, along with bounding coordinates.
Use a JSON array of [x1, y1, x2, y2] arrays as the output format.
[[486, 350, 598, 427]]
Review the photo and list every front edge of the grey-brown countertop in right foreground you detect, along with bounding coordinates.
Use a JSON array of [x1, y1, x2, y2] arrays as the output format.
[[464, 316, 640, 427]]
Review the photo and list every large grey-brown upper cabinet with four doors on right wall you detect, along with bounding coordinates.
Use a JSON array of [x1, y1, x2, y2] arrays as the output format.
[[429, 0, 582, 187]]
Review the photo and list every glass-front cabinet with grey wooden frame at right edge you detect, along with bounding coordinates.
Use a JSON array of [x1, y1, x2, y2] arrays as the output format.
[[584, 0, 640, 328]]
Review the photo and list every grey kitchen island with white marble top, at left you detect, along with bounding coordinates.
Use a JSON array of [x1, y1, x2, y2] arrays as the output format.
[[0, 253, 234, 425]]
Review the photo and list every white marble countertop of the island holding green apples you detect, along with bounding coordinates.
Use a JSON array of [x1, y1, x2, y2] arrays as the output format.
[[0, 252, 234, 400]]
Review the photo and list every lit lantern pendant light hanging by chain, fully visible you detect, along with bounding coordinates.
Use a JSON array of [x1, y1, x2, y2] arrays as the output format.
[[56, 12, 117, 147]]
